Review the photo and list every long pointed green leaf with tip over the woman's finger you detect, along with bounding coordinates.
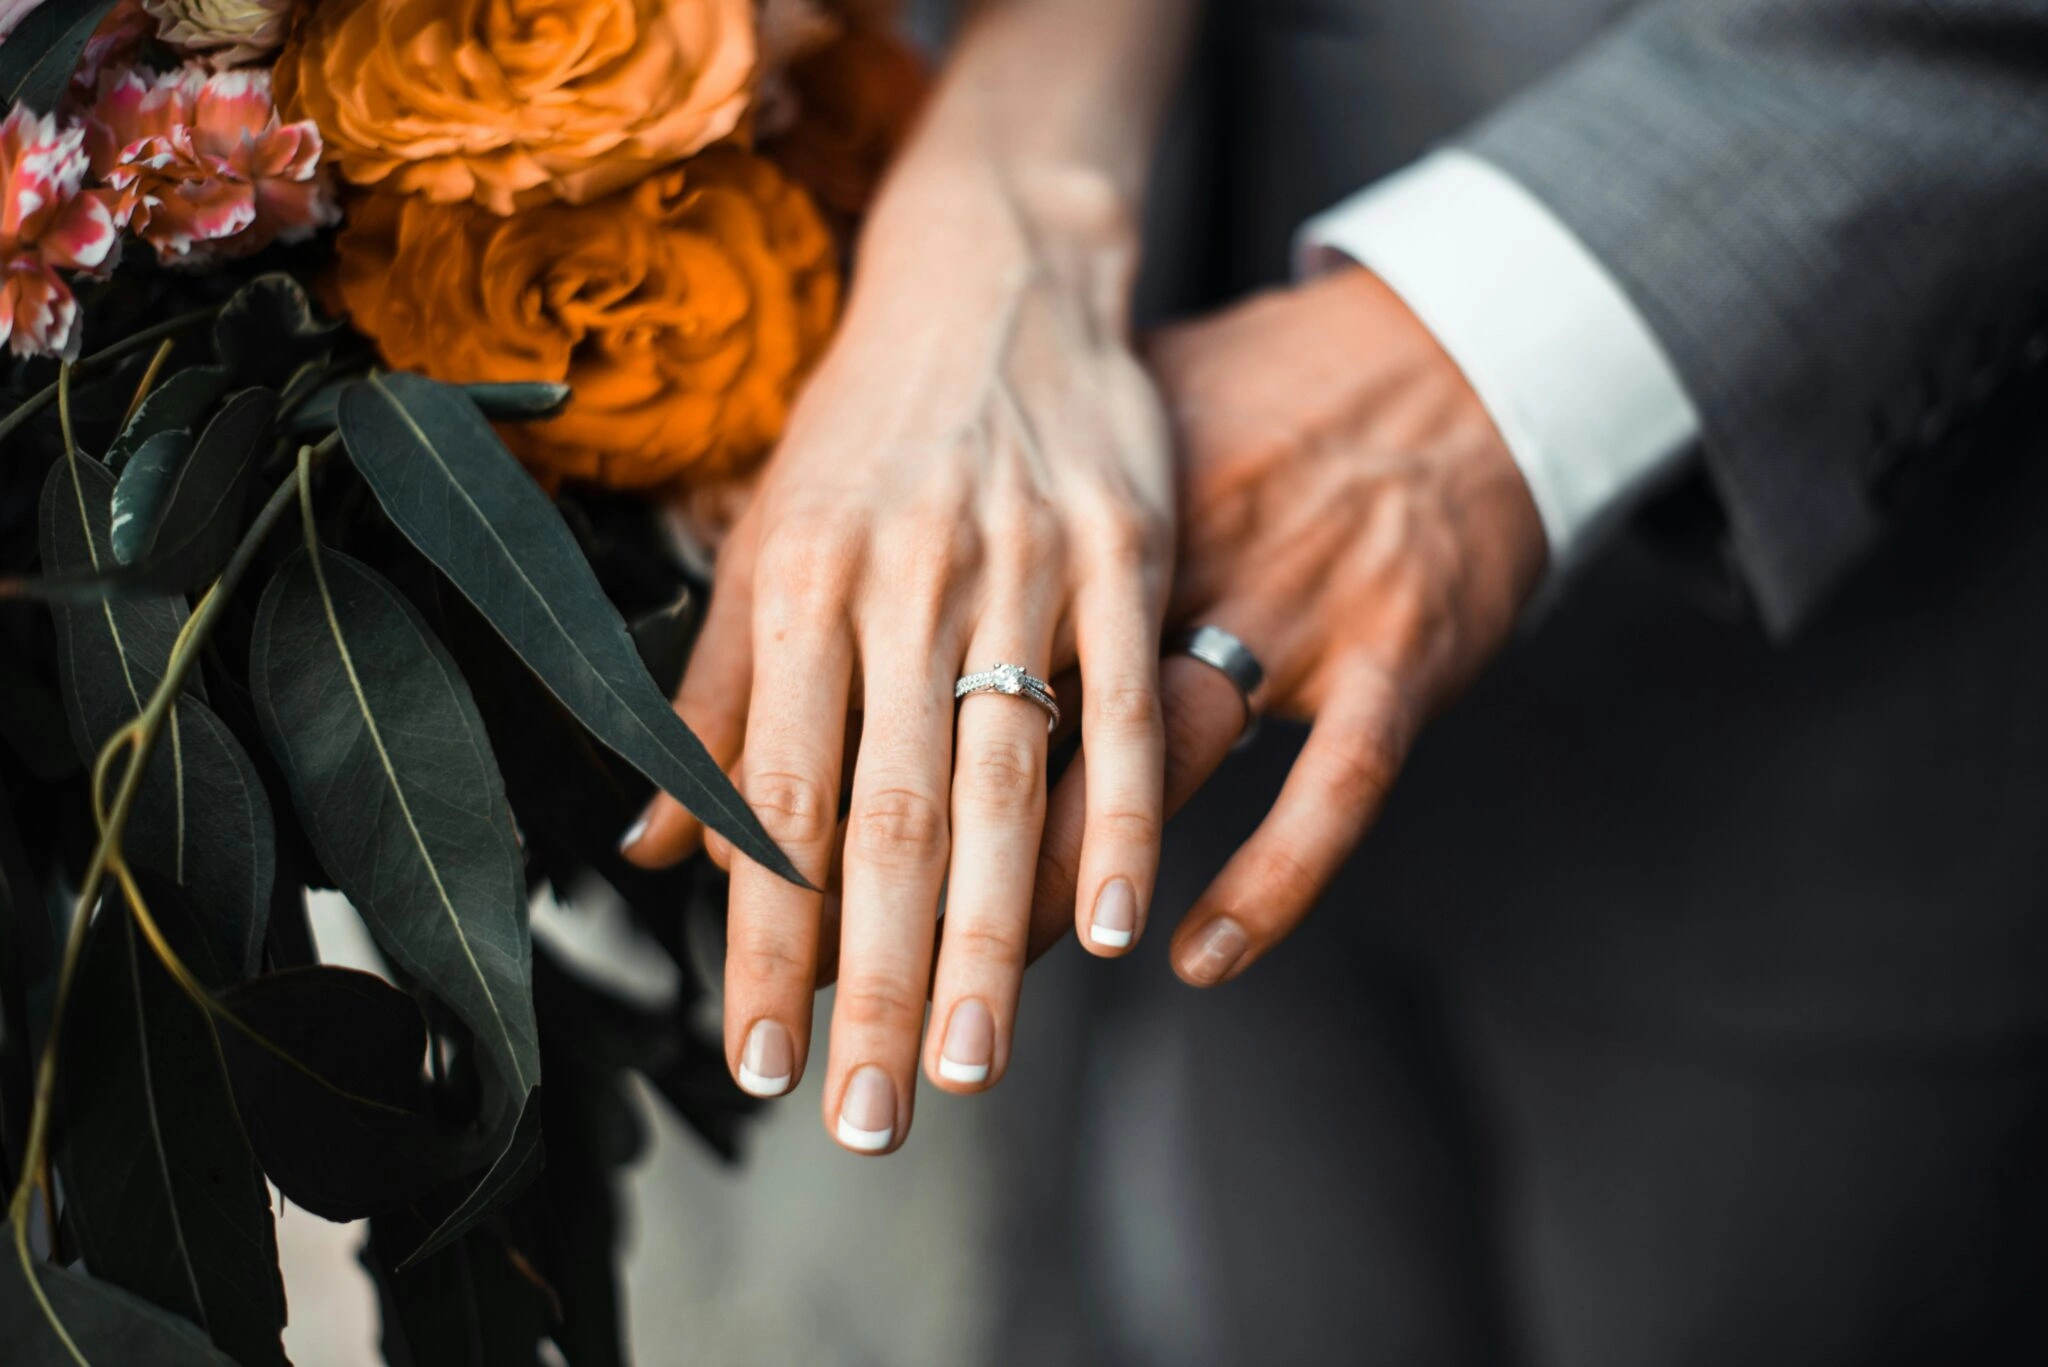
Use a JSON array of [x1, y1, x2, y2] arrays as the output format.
[[340, 375, 803, 883]]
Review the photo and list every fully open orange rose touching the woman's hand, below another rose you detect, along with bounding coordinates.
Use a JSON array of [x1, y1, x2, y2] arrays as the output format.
[[336, 146, 840, 488]]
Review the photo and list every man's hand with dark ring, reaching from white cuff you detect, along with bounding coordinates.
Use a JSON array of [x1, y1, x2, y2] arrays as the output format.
[[1032, 268, 1548, 986]]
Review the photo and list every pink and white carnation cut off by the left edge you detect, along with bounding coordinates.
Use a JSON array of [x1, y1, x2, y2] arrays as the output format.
[[0, 107, 121, 359]]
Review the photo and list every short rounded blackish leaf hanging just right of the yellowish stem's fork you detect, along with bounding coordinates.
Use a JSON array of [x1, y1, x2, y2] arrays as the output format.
[[221, 967, 473, 1219]]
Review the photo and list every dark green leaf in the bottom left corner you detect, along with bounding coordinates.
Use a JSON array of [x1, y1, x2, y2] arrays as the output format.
[[0, 1226, 236, 1367]]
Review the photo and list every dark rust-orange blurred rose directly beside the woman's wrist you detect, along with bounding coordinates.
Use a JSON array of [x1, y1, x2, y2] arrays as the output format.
[[762, 25, 930, 219]]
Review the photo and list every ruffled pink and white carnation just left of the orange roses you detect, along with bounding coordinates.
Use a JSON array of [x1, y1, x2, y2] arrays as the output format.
[[86, 64, 342, 266]]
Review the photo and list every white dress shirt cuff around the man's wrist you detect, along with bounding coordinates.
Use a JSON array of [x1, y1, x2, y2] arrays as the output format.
[[1298, 150, 1700, 570]]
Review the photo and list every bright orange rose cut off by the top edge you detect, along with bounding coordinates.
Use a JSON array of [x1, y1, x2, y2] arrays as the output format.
[[276, 0, 756, 213]]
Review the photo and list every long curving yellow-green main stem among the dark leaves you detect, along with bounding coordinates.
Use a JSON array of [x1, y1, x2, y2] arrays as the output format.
[[8, 432, 340, 1367]]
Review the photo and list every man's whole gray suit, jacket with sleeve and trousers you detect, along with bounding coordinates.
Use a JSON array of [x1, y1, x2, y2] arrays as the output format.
[[1079, 0, 2048, 1367]]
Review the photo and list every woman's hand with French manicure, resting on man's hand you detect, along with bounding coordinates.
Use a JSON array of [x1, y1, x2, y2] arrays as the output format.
[[629, 144, 1174, 1152]]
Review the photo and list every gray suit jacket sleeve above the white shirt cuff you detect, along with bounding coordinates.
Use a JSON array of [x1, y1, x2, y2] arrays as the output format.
[[1466, 0, 2048, 631]]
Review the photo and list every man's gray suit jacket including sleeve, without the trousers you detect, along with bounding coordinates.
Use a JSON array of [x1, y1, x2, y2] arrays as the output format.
[[1149, 0, 2048, 1049]]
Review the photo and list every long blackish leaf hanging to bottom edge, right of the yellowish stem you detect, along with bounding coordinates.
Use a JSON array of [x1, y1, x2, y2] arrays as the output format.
[[57, 900, 285, 1367]]
